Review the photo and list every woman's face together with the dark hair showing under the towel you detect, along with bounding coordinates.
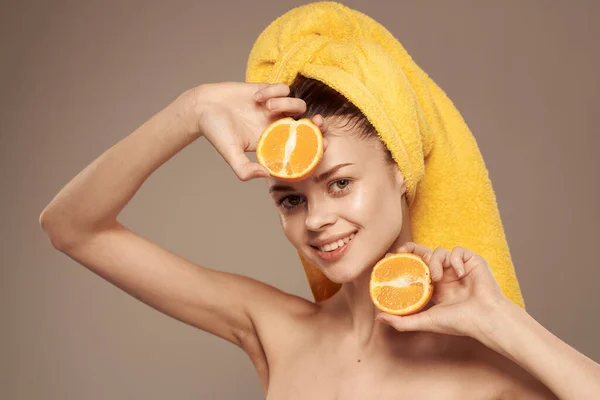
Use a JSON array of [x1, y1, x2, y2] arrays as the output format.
[[269, 75, 409, 284]]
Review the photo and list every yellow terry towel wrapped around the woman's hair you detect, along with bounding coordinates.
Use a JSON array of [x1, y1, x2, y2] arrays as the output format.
[[246, 2, 524, 307]]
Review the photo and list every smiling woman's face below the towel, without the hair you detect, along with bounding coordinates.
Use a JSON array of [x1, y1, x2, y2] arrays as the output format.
[[269, 122, 406, 283]]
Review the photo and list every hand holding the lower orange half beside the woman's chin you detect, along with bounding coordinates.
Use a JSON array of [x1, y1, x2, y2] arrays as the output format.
[[376, 242, 510, 339]]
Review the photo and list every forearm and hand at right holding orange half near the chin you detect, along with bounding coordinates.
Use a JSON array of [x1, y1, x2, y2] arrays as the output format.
[[377, 242, 600, 400]]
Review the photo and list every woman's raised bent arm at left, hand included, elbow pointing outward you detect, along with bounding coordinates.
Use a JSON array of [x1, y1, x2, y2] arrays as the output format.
[[40, 83, 305, 348]]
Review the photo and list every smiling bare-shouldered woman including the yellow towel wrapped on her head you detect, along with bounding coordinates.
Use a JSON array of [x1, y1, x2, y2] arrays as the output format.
[[40, 2, 600, 400]]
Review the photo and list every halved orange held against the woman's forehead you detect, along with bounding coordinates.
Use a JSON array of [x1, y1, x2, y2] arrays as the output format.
[[256, 117, 323, 181]]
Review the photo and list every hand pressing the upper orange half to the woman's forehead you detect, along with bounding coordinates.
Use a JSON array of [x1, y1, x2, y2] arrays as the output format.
[[189, 82, 310, 181]]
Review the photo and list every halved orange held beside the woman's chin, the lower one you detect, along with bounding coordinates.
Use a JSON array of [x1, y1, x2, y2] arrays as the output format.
[[369, 253, 433, 315]]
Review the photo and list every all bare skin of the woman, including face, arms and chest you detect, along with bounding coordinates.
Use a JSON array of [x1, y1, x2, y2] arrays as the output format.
[[40, 82, 600, 400]]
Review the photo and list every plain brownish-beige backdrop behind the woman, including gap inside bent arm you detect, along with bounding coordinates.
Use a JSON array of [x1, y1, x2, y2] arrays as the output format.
[[0, 0, 600, 400]]
